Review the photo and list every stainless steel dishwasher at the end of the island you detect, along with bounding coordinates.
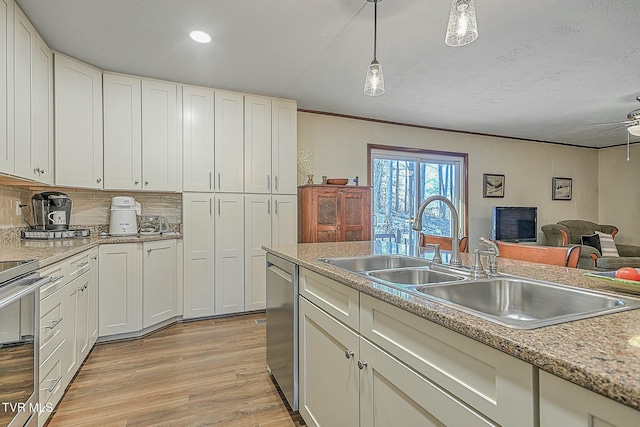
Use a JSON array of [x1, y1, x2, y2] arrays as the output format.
[[267, 253, 298, 411]]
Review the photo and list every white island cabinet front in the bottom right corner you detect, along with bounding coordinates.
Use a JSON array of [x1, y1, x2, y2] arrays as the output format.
[[540, 371, 640, 427]]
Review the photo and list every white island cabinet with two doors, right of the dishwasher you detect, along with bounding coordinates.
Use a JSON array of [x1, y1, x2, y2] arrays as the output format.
[[299, 268, 537, 427]]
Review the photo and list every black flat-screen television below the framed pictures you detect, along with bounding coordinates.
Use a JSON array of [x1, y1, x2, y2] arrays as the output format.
[[491, 206, 538, 243]]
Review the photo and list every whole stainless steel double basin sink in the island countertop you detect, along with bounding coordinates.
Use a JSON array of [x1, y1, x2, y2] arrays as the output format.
[[319, 255, 640, 329]]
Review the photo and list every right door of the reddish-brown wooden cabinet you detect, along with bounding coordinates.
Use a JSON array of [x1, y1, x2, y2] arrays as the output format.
[[339, 188, 371, 242]]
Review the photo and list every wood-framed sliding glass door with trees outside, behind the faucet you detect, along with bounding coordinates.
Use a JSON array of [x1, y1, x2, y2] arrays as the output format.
[[368, 144, 467, 245]]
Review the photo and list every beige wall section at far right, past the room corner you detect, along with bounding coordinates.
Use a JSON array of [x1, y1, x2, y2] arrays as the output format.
[[598, 144, 640, 245]]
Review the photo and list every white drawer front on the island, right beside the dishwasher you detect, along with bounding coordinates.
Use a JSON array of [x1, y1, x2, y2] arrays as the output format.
[[298, 268, 360, 331]]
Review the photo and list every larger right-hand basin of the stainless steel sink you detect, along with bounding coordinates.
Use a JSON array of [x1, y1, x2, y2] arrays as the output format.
[[414, 277, 640, 329]]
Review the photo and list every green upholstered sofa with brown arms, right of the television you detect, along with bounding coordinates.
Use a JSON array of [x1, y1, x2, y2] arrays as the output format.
[[542, 219, 640, 271]]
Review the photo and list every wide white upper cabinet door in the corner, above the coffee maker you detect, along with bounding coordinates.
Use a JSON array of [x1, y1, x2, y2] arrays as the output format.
[[54, 53, 103, 189]]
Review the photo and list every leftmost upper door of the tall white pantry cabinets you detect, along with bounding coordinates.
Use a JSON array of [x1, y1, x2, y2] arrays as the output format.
[[182, 86, 214, 191]]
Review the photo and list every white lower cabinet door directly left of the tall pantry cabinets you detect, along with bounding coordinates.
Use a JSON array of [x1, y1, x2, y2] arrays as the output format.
[[142, 240, 177, 328]]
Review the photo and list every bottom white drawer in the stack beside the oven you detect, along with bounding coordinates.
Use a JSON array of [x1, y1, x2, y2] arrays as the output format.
[[38, 343, 65, 427]]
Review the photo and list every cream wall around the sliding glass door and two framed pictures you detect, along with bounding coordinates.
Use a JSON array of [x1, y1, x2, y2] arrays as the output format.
[[298, 112, 596, 249]]
